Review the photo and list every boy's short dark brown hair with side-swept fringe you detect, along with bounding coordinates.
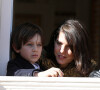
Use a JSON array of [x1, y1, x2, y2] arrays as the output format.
[[11, 23, 43, 57]]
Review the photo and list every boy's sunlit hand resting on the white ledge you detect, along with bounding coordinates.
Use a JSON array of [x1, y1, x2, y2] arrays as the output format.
[[36, 67, 64, 77]]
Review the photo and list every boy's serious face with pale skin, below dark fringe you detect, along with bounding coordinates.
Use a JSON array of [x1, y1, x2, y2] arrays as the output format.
[[17, 34, 42, 64]]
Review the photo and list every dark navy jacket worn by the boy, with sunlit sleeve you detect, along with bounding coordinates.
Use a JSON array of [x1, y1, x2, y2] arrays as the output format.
[[6, 56, 41, 76]]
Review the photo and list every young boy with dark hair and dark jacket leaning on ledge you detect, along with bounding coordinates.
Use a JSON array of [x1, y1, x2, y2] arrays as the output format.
[[7, 23, 63, 77]]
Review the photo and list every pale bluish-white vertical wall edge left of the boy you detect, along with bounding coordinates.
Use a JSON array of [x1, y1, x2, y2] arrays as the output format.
[[0, 0, 13, 76]]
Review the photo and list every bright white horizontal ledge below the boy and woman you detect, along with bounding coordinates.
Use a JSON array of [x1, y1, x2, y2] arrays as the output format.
[[0, 76, 100, 90]]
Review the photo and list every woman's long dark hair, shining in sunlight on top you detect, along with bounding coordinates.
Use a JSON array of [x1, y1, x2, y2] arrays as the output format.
[[46, 20, 91, 75]]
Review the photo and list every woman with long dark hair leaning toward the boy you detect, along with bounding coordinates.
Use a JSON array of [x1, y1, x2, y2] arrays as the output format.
[[40, 20, 96, 77]]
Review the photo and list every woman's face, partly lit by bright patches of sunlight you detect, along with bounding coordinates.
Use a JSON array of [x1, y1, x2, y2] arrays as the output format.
[[54, 32, 74, 68]]
